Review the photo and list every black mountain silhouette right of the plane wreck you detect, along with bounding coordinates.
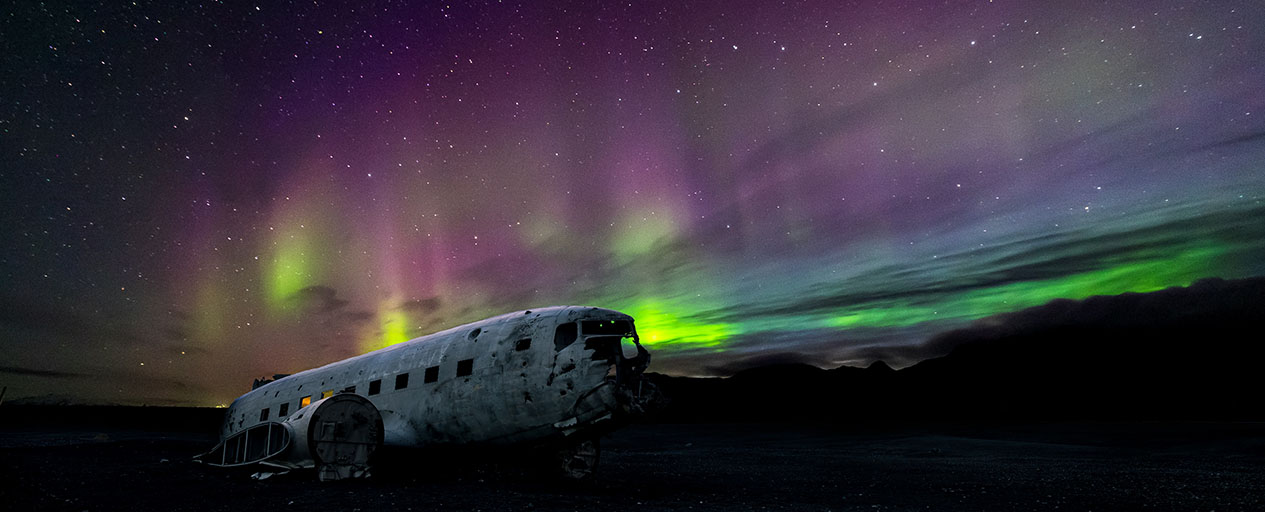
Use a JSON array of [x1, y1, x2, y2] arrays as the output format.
[[653, 278, 1265, 421]]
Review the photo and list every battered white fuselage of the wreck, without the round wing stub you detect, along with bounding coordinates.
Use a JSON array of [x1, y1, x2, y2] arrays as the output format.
[[220, 306, 648, 446]]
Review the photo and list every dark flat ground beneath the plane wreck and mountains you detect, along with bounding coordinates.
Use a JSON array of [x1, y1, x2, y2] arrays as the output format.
[[0, 422, 1265, 512]]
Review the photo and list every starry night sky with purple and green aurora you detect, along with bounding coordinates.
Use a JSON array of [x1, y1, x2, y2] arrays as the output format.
[[0, 0, 1265, 405]]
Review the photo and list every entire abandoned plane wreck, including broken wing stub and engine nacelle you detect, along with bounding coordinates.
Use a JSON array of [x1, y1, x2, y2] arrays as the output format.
[[196, 306, 658, 480]]
